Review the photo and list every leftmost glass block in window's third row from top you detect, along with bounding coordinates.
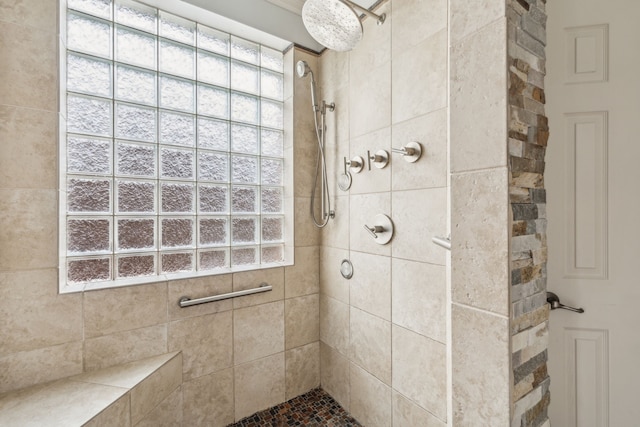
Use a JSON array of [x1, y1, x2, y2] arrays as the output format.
[[67, 53, 111, 97]]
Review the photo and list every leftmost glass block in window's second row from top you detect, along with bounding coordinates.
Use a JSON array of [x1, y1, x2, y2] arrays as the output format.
[[67, 12, 111, 58]]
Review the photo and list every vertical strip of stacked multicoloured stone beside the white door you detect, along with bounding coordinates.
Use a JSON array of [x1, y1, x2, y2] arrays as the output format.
[[507, 0, 550, 427]]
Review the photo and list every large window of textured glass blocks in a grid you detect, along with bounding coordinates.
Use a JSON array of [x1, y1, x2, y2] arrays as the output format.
[[60, 0, 287, 287]]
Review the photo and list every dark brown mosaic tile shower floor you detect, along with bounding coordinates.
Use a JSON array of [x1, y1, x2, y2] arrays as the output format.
[[227, 388, 362, 427]]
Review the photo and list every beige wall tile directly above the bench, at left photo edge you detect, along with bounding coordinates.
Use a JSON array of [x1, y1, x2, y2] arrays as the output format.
[[0, 341, 82, 393]]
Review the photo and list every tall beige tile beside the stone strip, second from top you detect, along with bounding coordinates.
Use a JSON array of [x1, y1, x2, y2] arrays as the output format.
[[450, 18, 507, 172]]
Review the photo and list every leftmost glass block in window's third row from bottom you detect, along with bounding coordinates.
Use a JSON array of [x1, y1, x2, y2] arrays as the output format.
[[67, 179, 111, 212]]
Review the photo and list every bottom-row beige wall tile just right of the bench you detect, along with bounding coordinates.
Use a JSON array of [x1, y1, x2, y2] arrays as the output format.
[[182, 368, 234, 427]]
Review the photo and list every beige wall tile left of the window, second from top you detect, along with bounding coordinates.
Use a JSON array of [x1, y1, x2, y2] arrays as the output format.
[[0, 22, 58, 111]]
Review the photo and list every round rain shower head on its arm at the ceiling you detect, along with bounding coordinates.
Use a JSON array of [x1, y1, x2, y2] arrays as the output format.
[[302, 0, 386, 52]]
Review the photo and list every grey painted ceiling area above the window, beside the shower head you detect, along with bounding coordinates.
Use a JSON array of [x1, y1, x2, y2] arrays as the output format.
[[178, 0, 378, 52]]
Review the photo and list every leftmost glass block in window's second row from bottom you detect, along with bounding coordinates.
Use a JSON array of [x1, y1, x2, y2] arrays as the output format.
[[67, 219, 111, 253]]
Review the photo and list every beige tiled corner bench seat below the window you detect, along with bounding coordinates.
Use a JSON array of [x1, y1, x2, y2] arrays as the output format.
[[0, 352, 182, 427]]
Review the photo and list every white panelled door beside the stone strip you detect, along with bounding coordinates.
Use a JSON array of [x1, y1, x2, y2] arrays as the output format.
[[545, 0, 640, 427]]
